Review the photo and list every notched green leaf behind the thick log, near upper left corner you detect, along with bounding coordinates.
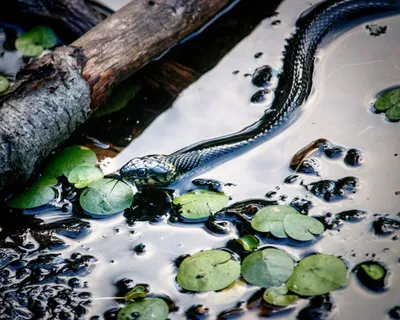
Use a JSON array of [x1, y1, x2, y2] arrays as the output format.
[[15, 26, 57, 57]]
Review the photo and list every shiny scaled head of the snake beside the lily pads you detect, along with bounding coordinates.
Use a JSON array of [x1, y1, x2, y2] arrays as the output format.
[[119, 155, 176, 186]]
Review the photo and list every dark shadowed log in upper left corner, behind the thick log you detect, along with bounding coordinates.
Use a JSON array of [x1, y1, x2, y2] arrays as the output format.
[[0, 0, 102, 40]]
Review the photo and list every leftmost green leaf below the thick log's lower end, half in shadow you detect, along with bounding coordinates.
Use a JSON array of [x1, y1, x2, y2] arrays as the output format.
[[7, 176, 58, 209]]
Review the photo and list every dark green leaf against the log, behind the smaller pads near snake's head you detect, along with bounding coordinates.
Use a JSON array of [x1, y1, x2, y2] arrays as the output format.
[[44, 146, 97, 177]]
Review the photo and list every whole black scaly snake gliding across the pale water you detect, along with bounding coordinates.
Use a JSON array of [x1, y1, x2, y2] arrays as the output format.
[[119, 0, 400, 186]]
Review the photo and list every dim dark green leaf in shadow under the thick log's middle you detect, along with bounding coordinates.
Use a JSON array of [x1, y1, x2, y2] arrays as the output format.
[[94, 79, 140, 117]]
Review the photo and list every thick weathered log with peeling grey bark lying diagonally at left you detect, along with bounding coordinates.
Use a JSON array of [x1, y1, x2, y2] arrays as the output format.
[[0, 0, 230, 191]]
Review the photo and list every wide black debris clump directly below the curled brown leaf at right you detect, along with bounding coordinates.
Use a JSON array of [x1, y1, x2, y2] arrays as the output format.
[[305, 177, 358, 202]]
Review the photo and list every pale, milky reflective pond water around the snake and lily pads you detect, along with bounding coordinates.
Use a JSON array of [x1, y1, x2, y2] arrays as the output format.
[[0, 0, 400, 319]]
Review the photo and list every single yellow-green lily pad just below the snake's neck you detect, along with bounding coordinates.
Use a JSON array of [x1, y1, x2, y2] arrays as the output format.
[[173, 189, 229, 220]]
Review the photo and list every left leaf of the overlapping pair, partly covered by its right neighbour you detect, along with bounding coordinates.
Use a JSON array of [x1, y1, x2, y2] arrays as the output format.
[[251, 205, 300, 238]]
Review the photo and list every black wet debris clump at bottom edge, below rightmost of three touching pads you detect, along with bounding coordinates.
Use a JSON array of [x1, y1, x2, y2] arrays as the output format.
[[297, 294, 334, 320]]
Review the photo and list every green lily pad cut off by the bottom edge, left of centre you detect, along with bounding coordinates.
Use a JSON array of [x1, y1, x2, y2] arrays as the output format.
[[117, 298, 169, 320]]
